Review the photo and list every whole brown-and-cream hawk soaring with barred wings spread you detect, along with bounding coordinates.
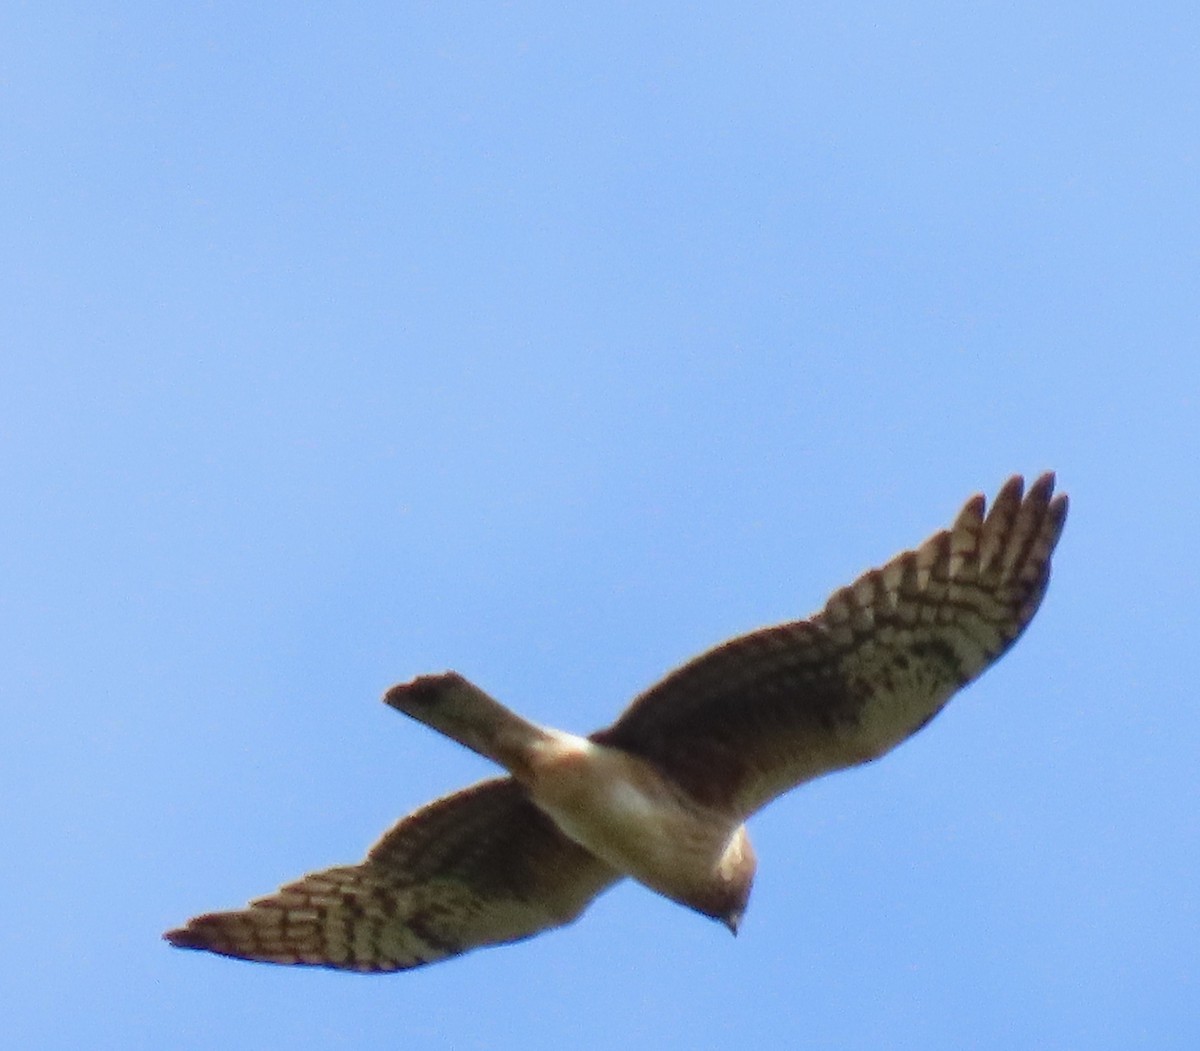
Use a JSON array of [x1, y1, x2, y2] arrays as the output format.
[[164, 474, 1067, 972]]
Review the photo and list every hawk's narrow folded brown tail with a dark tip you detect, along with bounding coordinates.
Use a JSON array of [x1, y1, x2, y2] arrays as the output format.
[[383, 672, 550, 780]]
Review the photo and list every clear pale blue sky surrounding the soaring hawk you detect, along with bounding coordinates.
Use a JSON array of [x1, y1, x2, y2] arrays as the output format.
[[0, 0, 1200, 1051]]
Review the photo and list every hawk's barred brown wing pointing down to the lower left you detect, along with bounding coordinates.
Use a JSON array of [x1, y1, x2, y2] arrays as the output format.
[[164, 777, 619, 971]]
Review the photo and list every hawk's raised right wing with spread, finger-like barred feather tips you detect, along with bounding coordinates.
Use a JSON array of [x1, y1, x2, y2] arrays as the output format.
[[593, 474, 1067, 815]]
